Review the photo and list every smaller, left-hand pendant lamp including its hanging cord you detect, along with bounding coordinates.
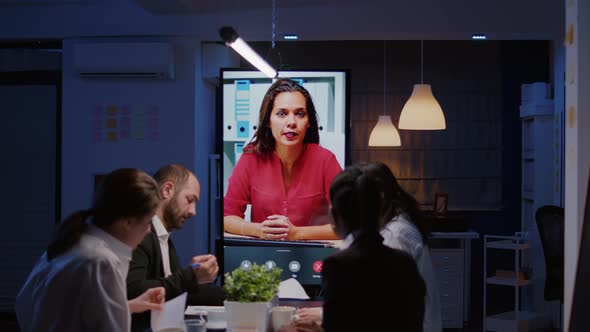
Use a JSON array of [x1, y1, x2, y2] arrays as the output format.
[[369, 41, 402, 147]]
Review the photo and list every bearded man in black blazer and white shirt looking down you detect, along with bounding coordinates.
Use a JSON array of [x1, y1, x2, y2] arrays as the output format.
[[127, 164, 225, 331]]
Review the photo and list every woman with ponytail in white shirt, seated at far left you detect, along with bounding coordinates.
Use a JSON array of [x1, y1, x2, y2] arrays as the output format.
[[15, 169, 165, 332]]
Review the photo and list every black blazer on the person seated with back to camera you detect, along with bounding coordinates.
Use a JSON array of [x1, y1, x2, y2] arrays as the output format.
[[322, 234, 426, 332]]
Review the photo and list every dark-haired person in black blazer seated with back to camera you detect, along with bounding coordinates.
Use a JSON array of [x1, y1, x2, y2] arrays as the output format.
[[300, 166, 426, 332]]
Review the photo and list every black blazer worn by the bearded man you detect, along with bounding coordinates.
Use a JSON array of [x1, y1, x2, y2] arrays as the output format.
[[127, 228, 225, 331]]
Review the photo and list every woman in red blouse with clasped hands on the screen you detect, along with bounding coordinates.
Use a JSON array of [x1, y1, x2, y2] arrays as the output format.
[[223, 79, 342, 240]]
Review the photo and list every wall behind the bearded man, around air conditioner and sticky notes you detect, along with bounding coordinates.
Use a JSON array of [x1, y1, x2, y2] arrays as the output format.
[[62, 37, 214, 263]]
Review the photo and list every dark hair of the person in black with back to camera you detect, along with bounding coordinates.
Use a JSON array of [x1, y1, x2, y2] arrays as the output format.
[[330, 166, 383, 237]]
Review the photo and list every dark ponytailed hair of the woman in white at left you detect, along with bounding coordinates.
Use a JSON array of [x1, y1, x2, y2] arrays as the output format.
[[47, 168, 160, 260]]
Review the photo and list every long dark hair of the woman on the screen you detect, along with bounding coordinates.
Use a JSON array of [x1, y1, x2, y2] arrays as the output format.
[[244, 78, 320, 158]]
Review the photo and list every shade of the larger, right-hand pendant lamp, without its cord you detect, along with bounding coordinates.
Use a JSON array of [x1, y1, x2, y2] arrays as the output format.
[[398, 84, 447, 130]]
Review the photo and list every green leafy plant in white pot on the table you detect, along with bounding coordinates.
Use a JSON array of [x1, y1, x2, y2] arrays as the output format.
[[223, 264, 283, 332]]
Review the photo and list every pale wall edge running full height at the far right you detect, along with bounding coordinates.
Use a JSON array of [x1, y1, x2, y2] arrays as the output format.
[[563, 0, 590, 331]]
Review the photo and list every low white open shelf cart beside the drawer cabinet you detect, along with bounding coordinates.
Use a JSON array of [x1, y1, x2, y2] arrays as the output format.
[[483, 233, 542, 332]]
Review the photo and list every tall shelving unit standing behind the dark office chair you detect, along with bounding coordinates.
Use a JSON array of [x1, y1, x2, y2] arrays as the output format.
[[520, 82, 558, 312]]
